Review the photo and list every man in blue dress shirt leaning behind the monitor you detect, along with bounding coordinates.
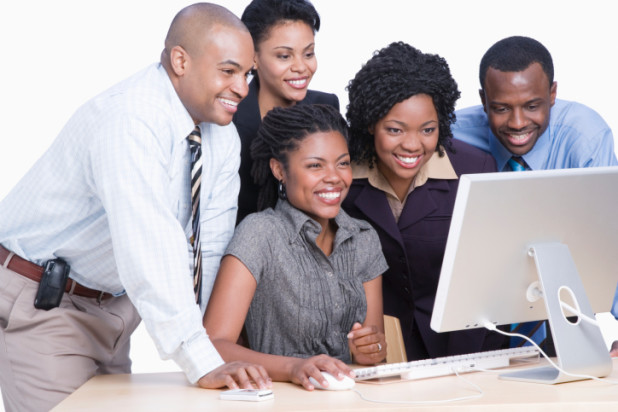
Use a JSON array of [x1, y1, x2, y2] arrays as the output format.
[[452, 36, 618, 356]]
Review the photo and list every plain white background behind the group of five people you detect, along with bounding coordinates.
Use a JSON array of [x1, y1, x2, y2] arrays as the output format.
[[0, 0, 618, 404]]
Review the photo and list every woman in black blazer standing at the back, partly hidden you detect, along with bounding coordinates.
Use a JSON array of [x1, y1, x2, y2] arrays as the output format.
[[233, 0, 339, 223]]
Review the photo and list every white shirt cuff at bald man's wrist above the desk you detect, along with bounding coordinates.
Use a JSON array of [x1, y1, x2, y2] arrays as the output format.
[[172, 333, 225, 383]]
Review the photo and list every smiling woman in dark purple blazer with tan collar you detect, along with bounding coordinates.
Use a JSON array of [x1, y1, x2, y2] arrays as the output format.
[[343, 43, 506, 360]]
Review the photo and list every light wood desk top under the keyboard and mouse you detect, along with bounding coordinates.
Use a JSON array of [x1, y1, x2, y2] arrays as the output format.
[[53, 359, 618, 412]]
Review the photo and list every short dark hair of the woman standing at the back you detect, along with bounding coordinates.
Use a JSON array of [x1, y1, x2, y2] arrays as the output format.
[[241, 0, 320, 50]]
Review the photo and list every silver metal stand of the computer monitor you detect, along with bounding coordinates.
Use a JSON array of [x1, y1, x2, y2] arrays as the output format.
[[500, 242, 612, 384]]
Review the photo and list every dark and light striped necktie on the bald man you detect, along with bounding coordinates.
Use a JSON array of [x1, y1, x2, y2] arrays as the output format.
[[187, 126, 202, 305]]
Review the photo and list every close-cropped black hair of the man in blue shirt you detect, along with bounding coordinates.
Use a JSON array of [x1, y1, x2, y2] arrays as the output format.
[[479, 36, 554, 90]]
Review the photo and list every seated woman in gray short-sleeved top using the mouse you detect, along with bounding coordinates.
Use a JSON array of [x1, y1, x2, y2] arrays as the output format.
[[204, 105, 387, 390]]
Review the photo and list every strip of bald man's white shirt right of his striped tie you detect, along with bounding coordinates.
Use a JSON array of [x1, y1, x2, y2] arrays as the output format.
[[200, 125, 240, 313]]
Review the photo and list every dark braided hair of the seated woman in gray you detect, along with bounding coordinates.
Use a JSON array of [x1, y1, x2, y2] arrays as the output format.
[[251, 104, 348, 211]]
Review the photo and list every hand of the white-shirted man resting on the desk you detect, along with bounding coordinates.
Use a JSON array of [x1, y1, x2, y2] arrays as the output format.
[[197, 362, 272, 389]]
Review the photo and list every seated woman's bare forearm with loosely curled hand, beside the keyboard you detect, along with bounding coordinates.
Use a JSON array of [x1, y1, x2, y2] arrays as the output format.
[[348, 276, 386, 365]]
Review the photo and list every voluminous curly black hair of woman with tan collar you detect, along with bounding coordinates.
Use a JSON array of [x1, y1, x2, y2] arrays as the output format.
[[346, 42, 460, 166]]
